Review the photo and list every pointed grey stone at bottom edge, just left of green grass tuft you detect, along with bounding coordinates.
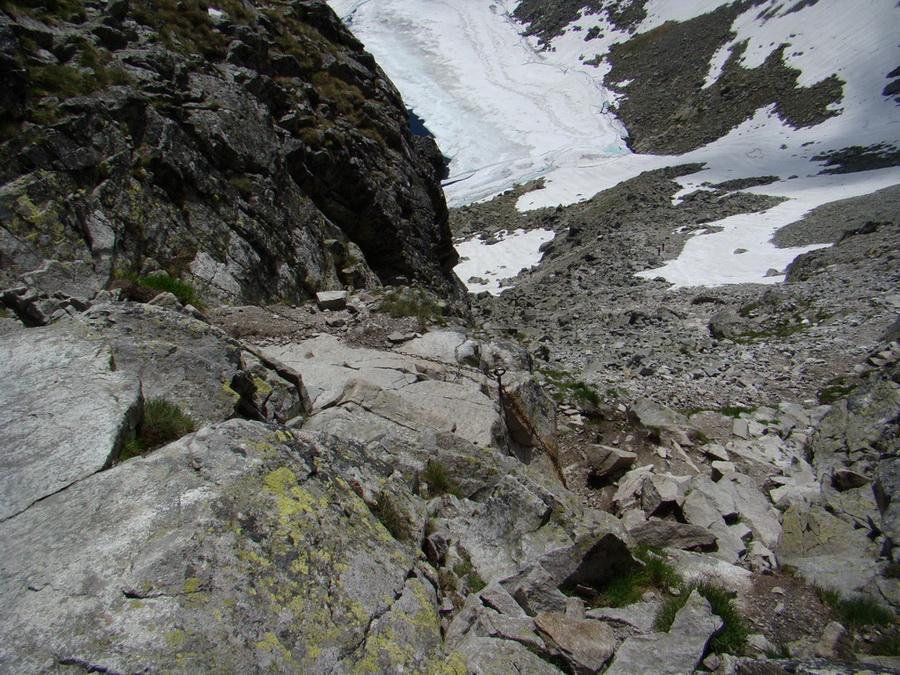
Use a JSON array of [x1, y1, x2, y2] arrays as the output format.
[[605, 591, 722, 675]]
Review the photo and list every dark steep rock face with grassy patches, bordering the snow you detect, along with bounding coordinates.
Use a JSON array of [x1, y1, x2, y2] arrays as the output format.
[[0, 0, 462, 302]]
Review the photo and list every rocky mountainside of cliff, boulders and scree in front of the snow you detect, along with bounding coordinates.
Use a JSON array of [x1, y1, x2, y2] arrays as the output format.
[[0, 0, 900, 675]]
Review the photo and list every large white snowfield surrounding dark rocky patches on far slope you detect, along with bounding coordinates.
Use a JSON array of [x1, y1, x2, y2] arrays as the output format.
[[330, 0, 900, 285]]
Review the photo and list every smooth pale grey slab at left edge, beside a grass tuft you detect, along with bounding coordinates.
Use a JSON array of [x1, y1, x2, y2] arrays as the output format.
[[0, 324, 141, 520]]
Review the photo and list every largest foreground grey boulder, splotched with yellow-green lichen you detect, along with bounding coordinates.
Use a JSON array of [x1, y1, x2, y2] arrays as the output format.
[[0, 420, 446, 673]]
